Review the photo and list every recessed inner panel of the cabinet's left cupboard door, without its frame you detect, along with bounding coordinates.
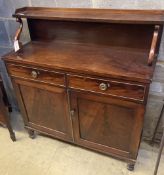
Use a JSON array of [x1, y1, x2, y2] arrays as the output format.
[[20, 85, 66, 133]]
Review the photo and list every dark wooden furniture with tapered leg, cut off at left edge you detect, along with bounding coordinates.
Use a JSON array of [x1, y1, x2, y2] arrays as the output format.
[[0, 76, 16, 141]]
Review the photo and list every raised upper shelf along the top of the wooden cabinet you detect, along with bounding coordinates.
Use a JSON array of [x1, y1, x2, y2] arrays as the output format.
[[13, 7, 164, 24]]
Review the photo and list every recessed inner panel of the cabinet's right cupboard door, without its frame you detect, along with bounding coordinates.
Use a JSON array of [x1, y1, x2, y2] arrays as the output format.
[[78, 99, 134, 151]]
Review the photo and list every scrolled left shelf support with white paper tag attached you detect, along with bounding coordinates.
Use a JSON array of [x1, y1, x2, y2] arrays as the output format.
[[14, 18, 23, 52]]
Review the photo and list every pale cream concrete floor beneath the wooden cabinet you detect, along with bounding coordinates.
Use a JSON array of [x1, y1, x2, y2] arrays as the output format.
[[0, 112, 164, 175]]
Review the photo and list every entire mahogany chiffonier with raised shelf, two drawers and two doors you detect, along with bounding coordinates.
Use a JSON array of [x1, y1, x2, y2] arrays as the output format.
[[4, 7, 164, 170]]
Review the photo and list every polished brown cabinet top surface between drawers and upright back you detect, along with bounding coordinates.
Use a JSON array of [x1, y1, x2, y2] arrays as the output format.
[[4, 41, 155, 82]]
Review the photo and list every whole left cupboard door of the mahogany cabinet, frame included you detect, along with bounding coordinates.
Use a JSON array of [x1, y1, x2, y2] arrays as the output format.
[[13, 79, 72, 141]]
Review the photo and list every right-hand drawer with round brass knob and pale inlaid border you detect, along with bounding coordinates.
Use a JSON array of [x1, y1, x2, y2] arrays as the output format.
[[68, 75, 145, 101]]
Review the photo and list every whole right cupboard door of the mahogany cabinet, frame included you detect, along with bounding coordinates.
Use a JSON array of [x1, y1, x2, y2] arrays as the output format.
[[71, 92, 144, 159]]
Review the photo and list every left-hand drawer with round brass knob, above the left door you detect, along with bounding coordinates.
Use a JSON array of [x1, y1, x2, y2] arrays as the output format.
[[7, 64, 65, 86]]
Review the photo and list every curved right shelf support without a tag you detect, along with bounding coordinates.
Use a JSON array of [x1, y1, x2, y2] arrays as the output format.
[[148, 25, 160, 66]]
